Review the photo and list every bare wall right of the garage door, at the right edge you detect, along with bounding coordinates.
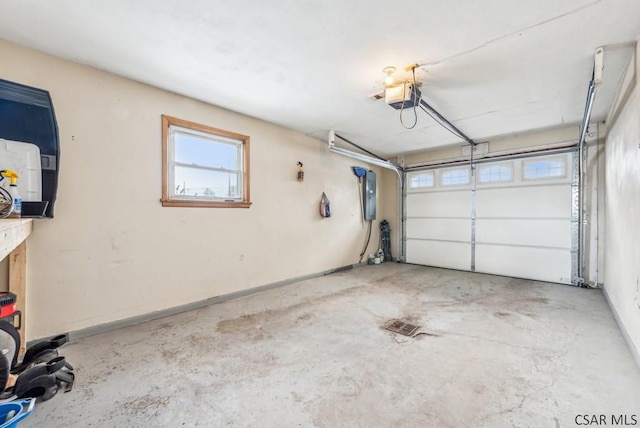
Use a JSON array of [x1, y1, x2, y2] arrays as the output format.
[[604, 40, 640, 364]]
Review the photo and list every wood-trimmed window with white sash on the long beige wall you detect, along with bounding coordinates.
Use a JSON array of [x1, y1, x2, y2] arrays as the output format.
[[162, 115, 251, 208]]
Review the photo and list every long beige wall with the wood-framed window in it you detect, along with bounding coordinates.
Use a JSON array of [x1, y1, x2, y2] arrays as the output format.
[[0, 41, 386, 339]]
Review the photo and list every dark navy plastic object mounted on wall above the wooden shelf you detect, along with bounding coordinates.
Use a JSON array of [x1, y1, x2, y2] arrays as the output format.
[[0, 79, 60, 217]]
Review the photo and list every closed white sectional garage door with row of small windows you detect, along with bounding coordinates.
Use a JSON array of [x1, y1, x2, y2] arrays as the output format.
[[405, 153, 578, 284]]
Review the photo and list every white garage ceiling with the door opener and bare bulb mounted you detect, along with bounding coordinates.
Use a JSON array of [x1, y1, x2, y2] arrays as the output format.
[[0, 0, 640, 155]]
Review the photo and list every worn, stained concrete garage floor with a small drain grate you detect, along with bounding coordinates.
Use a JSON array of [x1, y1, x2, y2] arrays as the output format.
[[20, 263, 640, 428]]
